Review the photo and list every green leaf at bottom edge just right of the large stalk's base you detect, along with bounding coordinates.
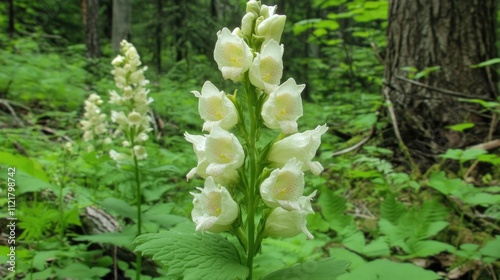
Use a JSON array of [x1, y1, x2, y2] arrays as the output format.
[[262, 258, 349, 280]]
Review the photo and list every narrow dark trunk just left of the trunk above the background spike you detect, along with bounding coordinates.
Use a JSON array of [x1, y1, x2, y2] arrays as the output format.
[[83, 0, 101, 57]]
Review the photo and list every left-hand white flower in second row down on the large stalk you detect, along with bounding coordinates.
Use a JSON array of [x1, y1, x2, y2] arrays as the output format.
[[192, 81, 238, 131]]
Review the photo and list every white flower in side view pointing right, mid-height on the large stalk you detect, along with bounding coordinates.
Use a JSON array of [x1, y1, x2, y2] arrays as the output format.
[[267, 124, 328, 175]]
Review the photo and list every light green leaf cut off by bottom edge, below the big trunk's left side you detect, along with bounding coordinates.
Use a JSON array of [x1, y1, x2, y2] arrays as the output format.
[[338, 260, 441, 280]]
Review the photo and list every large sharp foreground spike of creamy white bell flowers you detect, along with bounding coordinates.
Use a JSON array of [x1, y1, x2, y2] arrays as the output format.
[[185, 0, 328, 242]]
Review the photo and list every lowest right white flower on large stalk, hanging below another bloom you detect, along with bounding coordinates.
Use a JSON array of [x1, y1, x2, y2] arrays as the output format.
[[264, 207, 314, 239]]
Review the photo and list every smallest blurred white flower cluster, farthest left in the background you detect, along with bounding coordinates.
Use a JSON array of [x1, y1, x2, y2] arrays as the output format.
[[80, 93, 111, 152]]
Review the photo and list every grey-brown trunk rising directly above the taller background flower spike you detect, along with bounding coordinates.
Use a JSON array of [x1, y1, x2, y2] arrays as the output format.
[[111, 0, 132, 53]]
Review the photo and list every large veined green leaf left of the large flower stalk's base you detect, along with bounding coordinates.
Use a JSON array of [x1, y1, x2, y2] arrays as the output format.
[[134, 230, 248, 280]]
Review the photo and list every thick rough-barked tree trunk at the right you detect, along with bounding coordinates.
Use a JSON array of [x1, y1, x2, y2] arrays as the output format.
[[383, 0, 498, 161]]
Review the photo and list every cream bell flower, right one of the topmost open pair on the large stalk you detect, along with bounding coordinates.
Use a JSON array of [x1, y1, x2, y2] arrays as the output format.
[[249, 40, 284, 93]]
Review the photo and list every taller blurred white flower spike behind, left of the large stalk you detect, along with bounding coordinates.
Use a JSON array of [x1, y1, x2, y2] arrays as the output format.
[[109, 40, 153, 162]]
